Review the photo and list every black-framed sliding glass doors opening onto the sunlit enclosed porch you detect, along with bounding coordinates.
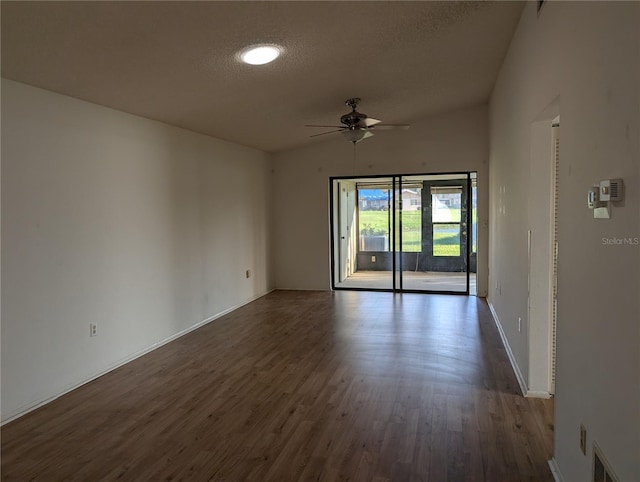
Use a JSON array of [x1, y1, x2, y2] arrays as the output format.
[[330, 172, 477, 295]]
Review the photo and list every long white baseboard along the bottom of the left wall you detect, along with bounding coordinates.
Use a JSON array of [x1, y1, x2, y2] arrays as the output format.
[[0, 289, 275, 426]]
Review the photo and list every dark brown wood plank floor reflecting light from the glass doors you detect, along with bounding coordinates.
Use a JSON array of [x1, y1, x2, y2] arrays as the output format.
[[2, 291, 553, 482]]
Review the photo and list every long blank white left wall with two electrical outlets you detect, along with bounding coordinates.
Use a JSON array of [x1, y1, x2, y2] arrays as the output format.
[[2, 80, 272, 420]]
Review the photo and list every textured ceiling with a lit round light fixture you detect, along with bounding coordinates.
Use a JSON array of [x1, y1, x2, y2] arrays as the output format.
[[1, 1, 523, 152]]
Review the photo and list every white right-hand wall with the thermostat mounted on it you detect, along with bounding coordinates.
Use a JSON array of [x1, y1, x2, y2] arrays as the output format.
[[489, 2, 640, 481]]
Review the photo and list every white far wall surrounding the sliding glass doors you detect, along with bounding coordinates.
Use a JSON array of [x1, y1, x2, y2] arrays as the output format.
[[274, 106, 488, 296]]
